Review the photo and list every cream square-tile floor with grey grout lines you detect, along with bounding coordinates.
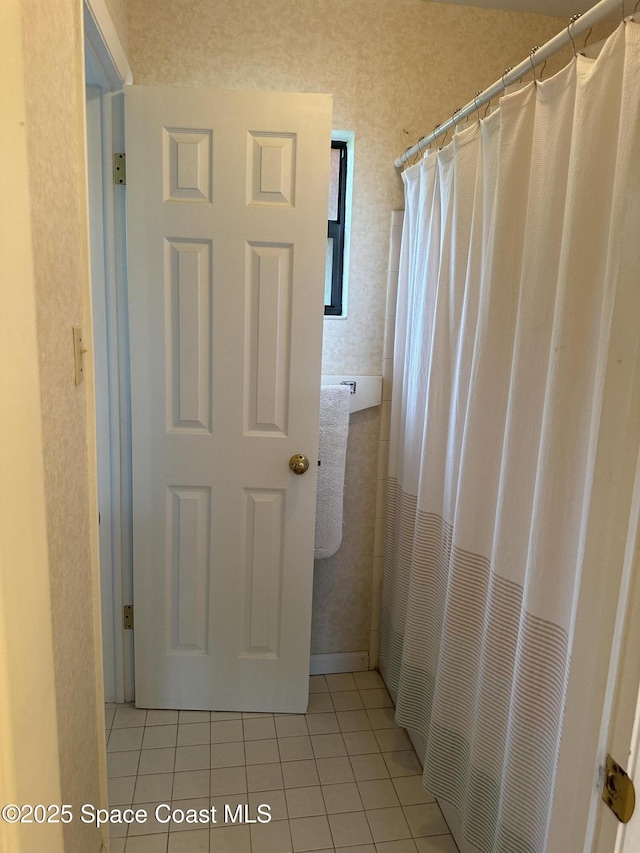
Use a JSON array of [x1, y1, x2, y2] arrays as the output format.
[[105, 672, 457, 853]]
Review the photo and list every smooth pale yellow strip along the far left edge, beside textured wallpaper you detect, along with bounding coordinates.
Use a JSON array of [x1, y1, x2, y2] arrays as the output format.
[[0, 6, 63, 853]]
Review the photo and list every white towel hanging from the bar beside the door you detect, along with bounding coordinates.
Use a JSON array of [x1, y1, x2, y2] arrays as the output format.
[[314, 385, 351, 560]]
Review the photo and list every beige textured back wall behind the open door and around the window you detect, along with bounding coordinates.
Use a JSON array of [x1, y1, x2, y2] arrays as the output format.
[[128, 0, 566, 653]]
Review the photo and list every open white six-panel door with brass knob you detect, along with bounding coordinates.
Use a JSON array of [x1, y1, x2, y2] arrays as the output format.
[[126, 86, 331, 712]]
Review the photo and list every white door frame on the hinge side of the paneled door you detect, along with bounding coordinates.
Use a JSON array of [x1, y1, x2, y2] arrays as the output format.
[[83, 0, 134, 702]]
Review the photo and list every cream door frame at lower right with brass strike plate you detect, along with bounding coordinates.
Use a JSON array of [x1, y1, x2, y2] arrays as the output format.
[[548, 255, 640, 853]]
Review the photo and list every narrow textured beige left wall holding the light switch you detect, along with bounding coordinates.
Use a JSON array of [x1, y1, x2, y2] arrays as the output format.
[[22, 0, 104, 853]]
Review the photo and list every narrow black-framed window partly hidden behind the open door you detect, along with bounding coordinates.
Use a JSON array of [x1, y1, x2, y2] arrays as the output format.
[[324, 139, 348, 317]]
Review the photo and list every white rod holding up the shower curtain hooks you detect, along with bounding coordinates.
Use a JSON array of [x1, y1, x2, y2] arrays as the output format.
[[394, 0, 624, 167]]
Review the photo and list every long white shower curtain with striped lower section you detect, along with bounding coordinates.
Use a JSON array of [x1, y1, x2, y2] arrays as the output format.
[[381, 23, 640, 853]]
